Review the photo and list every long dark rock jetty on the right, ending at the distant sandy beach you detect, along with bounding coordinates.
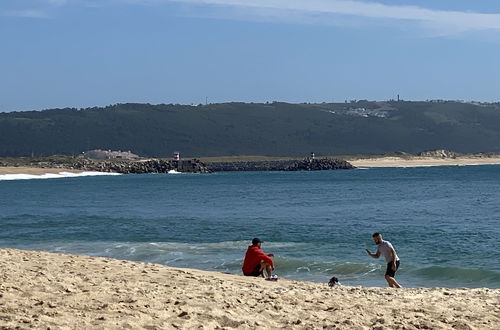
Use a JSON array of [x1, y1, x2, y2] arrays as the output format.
[[206, 158, 355, 172]]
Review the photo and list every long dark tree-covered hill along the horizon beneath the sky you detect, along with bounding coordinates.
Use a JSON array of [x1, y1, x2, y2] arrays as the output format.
[[0, 101, 500, 157]]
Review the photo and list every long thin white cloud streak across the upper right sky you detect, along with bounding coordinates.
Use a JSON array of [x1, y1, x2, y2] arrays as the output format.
[[128, 0, 500, 34]]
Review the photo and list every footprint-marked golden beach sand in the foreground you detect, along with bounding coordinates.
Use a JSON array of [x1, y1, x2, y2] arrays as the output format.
[[0, 249, 500, 329]]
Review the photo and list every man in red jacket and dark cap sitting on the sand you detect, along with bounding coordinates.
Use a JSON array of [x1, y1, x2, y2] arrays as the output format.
[[242, 237, 277, 279]]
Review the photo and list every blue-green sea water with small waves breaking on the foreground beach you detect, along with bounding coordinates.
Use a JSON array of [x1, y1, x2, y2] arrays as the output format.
[[0, 166, 500, 288]]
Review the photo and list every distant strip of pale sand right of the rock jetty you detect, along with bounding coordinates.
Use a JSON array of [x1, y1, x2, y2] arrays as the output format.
[[346, 156, 500, 167]]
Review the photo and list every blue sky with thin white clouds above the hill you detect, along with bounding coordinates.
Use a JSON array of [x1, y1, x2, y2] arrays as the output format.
[[0, 0, 500, 111]]
